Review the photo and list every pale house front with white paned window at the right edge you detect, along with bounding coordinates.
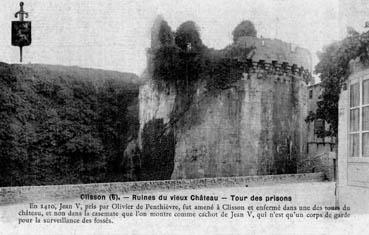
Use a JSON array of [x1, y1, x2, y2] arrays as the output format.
[[337, 58, 369, 213]]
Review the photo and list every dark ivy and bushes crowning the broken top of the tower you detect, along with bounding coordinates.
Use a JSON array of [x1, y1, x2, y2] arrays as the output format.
[[153, 21, 256, 88]]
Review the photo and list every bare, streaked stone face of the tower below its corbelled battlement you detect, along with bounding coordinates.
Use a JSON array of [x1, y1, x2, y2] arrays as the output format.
[[140, 63, 307, 179]]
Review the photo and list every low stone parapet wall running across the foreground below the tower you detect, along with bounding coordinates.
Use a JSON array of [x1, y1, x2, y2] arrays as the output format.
[[0, 173, 324, 205]]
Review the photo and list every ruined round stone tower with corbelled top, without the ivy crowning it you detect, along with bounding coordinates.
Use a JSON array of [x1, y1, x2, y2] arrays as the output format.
[[139, 17, 311, 180]]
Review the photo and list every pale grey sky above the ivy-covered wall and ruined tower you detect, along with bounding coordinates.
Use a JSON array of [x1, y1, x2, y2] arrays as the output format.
[[0, 0, 340, 75]]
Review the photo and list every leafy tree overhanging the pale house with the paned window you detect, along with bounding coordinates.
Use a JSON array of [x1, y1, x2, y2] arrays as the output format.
[[306, 29, 369, 137]]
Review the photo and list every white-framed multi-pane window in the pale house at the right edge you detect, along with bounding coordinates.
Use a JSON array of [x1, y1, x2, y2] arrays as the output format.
[[349, 79, 369, 158]]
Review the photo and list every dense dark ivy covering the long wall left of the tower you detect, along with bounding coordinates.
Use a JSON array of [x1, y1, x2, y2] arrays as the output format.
[[0, 64, 138, 186]]
